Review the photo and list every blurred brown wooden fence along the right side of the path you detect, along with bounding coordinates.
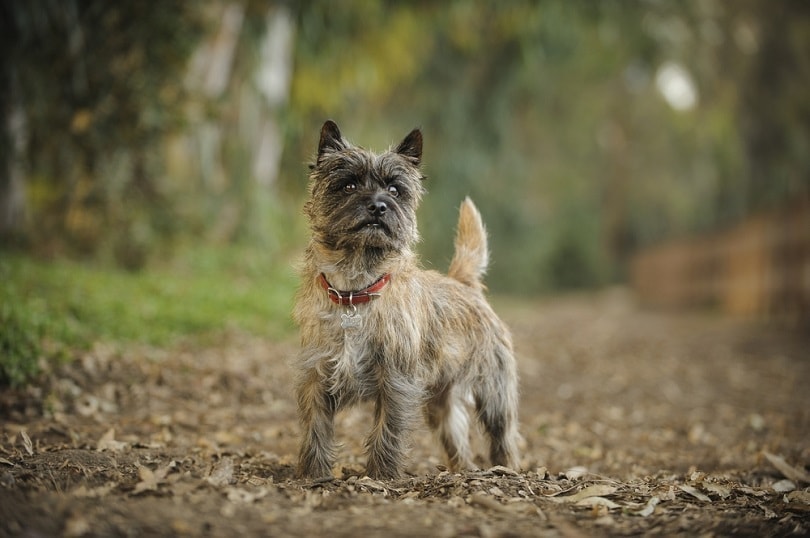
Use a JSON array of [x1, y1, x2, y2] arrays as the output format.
[[631, 199, 810, 327]]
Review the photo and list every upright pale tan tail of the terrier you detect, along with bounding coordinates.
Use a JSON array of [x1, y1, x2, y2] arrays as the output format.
[[447, 198, 489, 290]]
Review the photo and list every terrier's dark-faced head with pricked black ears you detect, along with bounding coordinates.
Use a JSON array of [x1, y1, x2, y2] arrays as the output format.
[[304, 121, 424, 253]]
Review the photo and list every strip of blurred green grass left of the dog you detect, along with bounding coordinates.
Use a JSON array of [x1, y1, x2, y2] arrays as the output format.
[[0, 248, 296, 385]]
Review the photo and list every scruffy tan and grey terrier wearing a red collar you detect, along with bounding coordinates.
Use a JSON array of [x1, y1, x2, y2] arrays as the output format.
[[294, 121, 519, 478]]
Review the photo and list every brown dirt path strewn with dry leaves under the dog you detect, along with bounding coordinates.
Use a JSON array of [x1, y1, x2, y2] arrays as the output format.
[[0, 290, 810, 537]]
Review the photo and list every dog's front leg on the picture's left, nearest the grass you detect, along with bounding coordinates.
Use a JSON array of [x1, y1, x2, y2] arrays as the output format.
[[297, 369, 337, 478]]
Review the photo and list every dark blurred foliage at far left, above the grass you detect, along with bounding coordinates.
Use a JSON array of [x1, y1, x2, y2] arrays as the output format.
[[0, 0, 205, 267]]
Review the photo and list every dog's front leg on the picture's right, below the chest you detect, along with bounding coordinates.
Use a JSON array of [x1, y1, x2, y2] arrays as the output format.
[[366, 372, 422, 478]]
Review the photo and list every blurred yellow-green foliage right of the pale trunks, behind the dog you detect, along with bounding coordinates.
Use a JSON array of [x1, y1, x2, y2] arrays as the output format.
[[287, 1, 810, 293]]
